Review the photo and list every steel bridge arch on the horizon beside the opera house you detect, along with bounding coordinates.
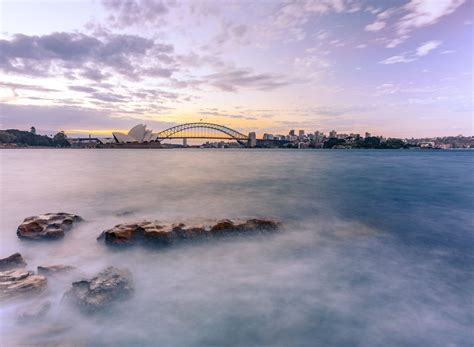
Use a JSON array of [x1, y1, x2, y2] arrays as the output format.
[[156, 122, 248, 143]]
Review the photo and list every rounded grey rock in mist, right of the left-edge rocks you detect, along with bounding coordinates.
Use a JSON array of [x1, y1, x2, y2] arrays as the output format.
[[64, 266, 133, 313]]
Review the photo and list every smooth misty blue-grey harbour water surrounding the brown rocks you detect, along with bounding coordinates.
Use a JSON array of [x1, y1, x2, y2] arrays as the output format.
[[0, 150, 474, 347]]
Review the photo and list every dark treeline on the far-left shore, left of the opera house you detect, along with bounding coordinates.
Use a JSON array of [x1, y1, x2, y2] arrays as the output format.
[[0, 129, 71, 147]]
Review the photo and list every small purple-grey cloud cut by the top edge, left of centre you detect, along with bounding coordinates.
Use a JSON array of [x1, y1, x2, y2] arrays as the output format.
[[102, 0, 174, 28]]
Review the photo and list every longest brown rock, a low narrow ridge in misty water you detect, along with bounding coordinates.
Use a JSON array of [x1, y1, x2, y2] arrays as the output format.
[[97, 219, 280, 246]]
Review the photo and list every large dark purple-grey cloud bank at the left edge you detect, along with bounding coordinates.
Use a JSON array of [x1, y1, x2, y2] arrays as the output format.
[[0, 32, 173, 81]]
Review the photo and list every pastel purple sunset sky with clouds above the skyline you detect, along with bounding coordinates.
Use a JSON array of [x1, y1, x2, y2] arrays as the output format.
[[0, 0, 474, 138]]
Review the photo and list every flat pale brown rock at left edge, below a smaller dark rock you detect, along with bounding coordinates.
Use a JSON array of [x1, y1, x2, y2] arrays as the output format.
[[0, 270, 47, 299]]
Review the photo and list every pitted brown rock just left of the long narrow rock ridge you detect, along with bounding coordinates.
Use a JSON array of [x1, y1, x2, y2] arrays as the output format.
[[16, 212, 82, 240]]
